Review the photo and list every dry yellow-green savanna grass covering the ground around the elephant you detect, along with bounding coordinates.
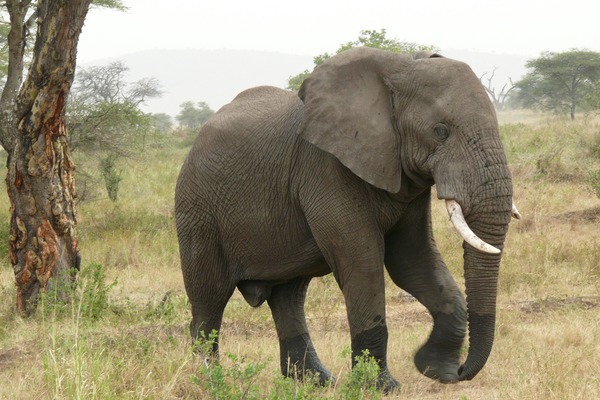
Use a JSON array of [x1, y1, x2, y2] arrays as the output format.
[[0, 113, 600, 399]]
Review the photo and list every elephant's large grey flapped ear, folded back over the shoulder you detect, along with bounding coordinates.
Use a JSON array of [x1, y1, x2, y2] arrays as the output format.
[[298, 48, 407, 193]]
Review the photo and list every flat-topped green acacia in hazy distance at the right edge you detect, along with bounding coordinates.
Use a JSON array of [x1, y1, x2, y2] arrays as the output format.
[[515, 49, 600, 119]]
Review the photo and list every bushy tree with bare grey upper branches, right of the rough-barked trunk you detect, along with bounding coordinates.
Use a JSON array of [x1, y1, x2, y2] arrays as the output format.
[[67, 61, 162, 201]]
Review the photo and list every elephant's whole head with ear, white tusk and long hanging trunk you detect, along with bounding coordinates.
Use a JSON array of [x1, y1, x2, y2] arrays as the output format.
[[299, 48, 512, 380]]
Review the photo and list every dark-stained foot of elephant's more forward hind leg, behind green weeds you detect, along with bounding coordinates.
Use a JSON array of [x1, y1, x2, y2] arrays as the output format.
[[279, 334, 335, 386]]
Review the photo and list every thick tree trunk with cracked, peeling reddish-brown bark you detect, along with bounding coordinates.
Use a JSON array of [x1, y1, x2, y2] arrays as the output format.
[[6, 0, 91, 314]]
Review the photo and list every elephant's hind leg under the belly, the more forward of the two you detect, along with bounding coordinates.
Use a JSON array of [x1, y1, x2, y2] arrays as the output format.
[[267, 278, 332, 384]]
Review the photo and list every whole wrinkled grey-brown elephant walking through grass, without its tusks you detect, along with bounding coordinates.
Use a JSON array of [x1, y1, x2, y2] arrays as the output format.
[[176, 48, 512, 390]]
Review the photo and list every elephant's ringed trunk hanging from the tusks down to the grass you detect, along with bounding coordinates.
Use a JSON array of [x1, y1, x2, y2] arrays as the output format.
[[459, 195, 512, 380]]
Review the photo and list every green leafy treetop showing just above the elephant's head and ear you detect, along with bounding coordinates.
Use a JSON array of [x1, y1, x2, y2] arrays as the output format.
[[287, 29, 436, 90]]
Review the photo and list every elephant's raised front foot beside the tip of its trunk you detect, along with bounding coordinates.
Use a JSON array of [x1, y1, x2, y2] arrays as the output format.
[[415, 342, 460, 383]]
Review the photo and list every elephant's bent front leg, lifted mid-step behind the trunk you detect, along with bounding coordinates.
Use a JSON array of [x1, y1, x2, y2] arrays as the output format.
[[385, 194, 467, 383]]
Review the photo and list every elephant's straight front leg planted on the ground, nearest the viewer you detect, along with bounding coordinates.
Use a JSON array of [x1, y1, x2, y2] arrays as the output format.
[[303, 184, 399, 391]]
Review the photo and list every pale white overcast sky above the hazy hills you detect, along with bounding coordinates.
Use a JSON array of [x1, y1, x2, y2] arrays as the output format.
[[78, 0, 600, 63]]
